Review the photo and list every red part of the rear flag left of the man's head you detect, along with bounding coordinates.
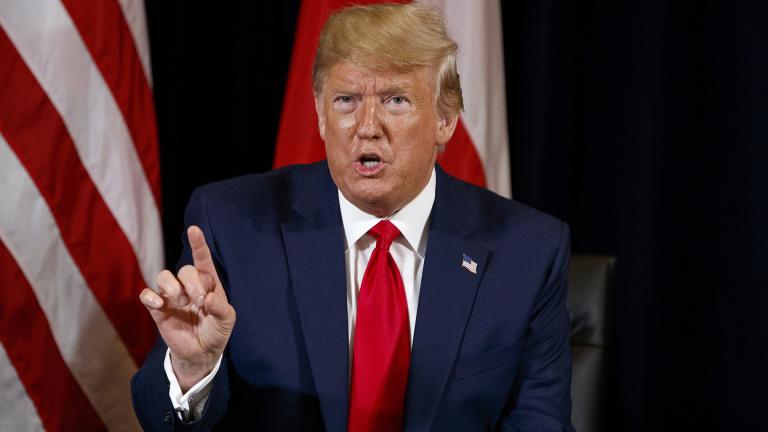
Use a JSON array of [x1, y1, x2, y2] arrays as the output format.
[[274, 0, 412, 168]]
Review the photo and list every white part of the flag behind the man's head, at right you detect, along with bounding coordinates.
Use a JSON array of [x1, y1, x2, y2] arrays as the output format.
[[421, 0, 512, 198]]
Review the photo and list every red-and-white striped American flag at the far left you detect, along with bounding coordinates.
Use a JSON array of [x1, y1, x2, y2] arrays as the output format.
[[0, 0, 163, 431]]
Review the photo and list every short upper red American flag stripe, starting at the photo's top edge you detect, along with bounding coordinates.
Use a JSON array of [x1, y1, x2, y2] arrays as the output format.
[[62, 0, 161, 208]]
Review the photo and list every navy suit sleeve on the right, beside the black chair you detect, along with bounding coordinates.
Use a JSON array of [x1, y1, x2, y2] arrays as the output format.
[[498, 223, 575, 432]]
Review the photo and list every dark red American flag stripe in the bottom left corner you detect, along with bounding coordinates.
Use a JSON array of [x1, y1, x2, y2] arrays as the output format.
[[0, 242, 106, 431]]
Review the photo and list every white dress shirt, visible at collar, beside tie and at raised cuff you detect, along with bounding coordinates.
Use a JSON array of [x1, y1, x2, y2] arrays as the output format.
[[164, 169, 436, 421]]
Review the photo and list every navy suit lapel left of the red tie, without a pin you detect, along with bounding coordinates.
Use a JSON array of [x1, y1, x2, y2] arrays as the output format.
[[282, 164, 349, 431]]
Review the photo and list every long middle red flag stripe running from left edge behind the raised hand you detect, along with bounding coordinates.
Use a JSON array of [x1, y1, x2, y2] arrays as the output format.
[[0, 28, 155, 364]]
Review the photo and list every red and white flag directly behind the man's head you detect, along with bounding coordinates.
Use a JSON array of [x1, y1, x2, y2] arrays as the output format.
[[274, 0, 511, 197]]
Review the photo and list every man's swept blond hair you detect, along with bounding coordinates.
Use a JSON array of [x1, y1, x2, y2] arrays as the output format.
[[312, 3, 464, 115]]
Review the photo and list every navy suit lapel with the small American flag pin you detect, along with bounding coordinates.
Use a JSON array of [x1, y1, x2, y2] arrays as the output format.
[[404, 168, 490, 431]]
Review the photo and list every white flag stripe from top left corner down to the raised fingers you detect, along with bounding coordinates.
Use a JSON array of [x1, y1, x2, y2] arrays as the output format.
[[0, 0, 164, 286]]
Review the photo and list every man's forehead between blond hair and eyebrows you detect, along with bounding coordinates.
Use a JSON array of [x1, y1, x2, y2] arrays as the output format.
[[324, 63, 432, 91]]
